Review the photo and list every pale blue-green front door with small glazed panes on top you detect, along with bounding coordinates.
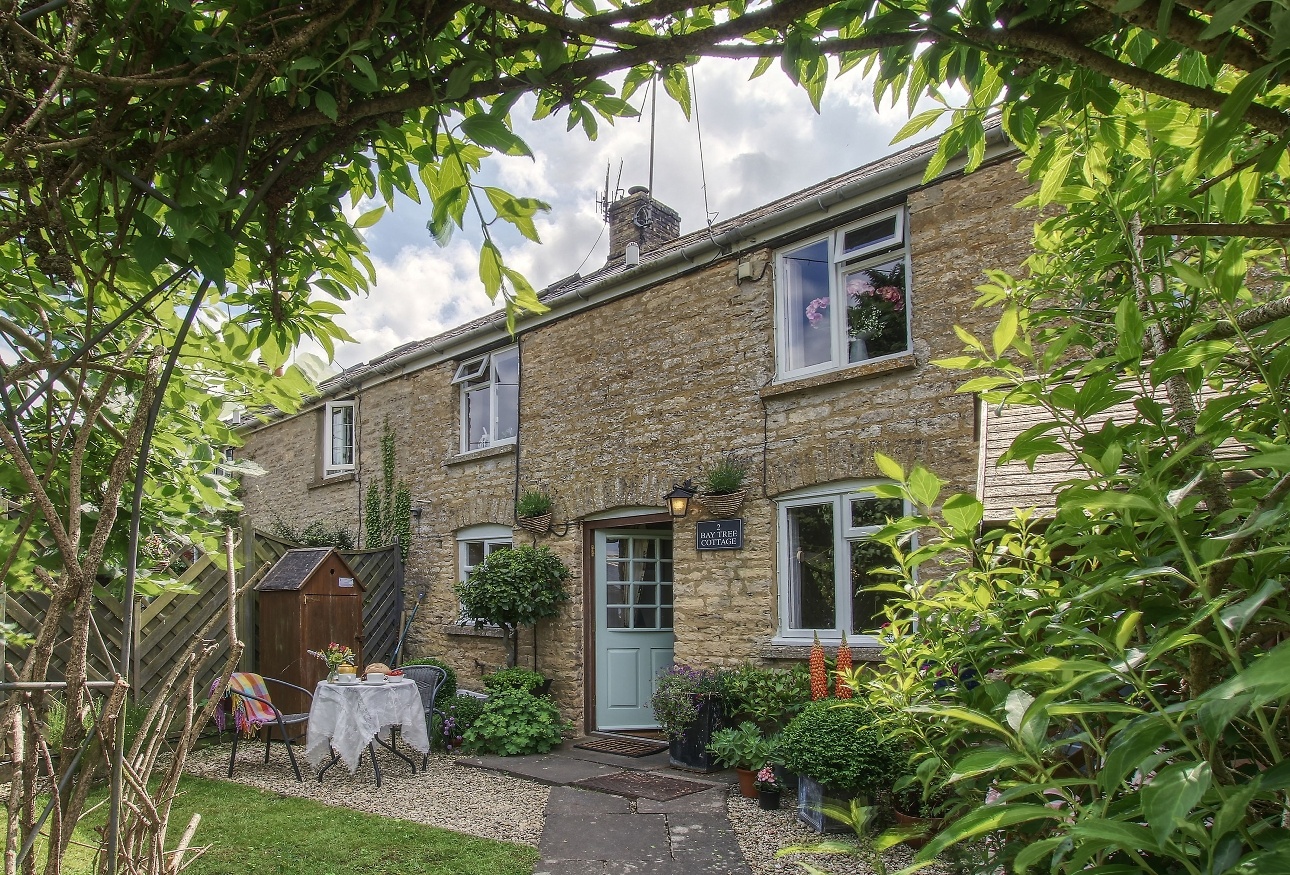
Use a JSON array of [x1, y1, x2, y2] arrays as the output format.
[[596, 529, 673, 729]]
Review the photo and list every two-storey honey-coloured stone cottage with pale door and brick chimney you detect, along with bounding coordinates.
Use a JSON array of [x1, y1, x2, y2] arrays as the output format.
[[239, 128, 1033, 732]]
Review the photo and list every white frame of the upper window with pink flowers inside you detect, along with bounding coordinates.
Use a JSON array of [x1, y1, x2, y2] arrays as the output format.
[[775, 206, 913, 381]]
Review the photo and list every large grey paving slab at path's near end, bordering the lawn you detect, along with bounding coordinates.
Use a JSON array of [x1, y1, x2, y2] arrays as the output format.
[[538, 805, 672, 865]]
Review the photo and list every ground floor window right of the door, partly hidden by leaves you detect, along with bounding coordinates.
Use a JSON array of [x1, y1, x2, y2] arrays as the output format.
[[778, 484, 906, 643]]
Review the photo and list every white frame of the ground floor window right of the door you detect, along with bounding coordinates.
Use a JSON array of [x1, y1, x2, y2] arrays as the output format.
[[771, 480, 912, 647]]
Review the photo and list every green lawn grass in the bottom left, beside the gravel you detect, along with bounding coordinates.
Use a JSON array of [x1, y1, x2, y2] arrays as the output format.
[[21, 777, 538, 875]]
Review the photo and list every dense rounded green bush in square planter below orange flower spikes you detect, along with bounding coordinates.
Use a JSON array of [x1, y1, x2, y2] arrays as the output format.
[[779, 699, 909, 800]]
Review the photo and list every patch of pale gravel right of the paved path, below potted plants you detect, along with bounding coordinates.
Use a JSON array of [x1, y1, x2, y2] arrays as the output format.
[[726, 787, 949, 875]]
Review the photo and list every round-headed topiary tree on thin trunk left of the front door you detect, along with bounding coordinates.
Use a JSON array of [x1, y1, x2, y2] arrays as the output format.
[[455, 547, 571, 666]]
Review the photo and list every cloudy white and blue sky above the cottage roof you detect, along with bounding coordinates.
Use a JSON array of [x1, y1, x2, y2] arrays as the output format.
[[321, 55, 939, 368]]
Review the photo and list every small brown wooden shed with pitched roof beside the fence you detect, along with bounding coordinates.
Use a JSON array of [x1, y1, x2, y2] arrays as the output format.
[[255, 547, 364, 714]]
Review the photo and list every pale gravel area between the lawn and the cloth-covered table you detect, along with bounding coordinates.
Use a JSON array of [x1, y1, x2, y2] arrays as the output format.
[[187, 743, 547, 847]]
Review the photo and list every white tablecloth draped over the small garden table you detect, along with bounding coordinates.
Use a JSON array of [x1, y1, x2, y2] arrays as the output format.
[[304, 678, 430, 773]]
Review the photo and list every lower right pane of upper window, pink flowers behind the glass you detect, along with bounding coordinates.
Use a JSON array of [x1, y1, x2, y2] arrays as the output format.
[[842, 258, 909, 361]]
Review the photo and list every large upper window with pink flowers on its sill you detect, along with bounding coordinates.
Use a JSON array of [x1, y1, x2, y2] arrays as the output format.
[[775, 209, 909, 378]]
